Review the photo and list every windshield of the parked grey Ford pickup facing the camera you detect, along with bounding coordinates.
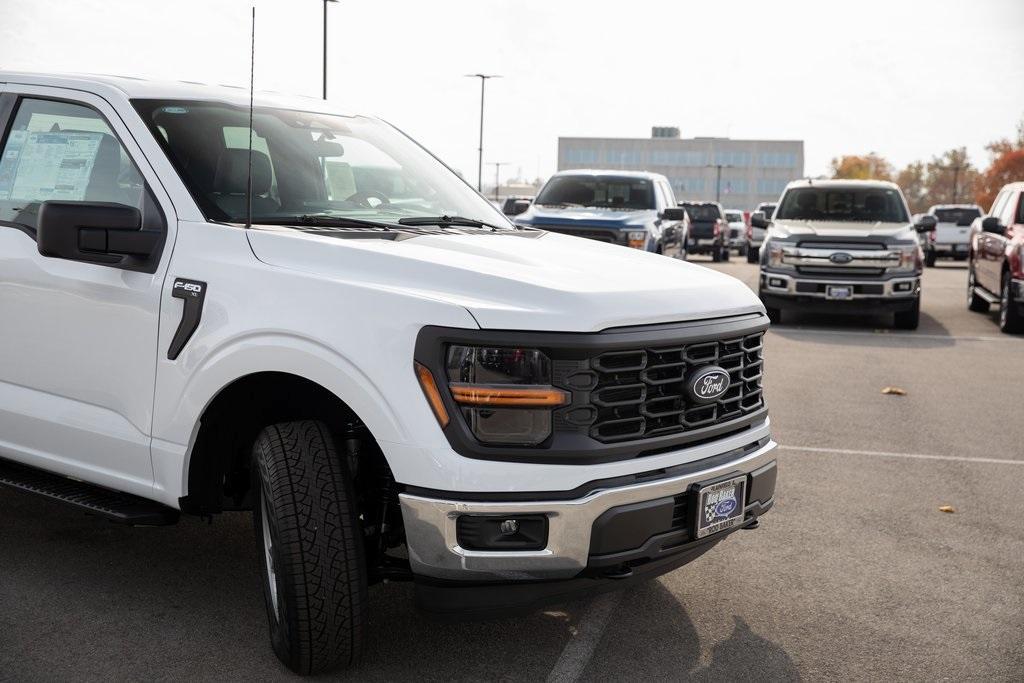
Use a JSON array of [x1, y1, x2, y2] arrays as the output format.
[[775, 187, 908, 223]]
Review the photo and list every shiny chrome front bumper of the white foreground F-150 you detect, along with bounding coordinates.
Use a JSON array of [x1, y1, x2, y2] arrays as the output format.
[[399, 440, 776, 581]]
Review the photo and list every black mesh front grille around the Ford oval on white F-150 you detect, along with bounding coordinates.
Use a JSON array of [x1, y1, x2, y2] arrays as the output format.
[[573, 332, 764, 443]]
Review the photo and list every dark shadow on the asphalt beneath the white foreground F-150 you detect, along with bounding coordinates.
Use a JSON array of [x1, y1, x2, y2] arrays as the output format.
[[0, 489, 797, 681]]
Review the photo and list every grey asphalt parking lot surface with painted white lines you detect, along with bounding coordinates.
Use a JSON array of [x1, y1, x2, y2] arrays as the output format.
[[0, 260, 1024, 681]]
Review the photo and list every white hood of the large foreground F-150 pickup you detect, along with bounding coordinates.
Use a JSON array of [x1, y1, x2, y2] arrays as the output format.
[[247, 226, 764, 332]]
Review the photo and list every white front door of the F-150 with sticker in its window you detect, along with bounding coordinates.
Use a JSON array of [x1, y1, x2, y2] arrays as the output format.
[[0, 84, 174, 496]]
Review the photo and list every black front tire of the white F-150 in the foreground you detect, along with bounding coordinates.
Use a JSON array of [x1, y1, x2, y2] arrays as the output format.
[[253, 420, 367, 675]]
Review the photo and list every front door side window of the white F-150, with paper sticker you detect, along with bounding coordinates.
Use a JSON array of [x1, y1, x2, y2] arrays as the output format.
[[0, 98, 145, 227]]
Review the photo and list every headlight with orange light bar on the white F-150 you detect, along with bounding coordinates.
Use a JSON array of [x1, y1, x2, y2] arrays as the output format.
[[446, 345, 569, 445]]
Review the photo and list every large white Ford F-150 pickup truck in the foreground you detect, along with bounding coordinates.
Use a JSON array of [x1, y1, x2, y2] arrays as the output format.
[[0, 73, 776, 674]]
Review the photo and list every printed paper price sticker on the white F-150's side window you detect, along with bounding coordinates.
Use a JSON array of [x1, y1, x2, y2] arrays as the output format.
[[6, 131, 103, 202]]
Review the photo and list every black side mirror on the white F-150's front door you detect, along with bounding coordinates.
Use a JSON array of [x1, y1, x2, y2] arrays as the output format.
[[36, 202, 155, 265]]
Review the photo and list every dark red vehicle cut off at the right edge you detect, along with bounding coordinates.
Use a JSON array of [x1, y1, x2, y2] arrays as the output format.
[[967, 182, 1024, 334]]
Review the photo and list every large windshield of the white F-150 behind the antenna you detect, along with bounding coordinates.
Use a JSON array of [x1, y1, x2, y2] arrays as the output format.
[[133, 99, 512, 228]]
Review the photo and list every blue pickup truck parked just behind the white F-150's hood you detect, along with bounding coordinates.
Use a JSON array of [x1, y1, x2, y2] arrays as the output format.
[[514, 170, 689, 258]]
